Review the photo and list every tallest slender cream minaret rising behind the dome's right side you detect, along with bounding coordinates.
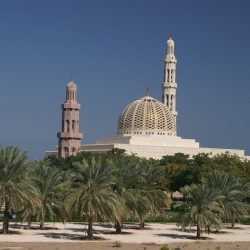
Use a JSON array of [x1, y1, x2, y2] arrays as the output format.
[[162, 38, 177, 123]]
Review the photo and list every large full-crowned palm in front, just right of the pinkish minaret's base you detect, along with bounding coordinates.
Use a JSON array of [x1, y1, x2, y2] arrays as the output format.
[[67, 155, 122, 239]]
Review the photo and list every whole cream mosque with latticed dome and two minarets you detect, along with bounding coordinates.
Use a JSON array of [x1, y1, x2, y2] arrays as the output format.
[[46, 38, 250, 159]]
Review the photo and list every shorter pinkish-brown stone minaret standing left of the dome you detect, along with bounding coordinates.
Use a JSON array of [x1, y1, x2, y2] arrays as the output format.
[[57, 80, 83, 158]]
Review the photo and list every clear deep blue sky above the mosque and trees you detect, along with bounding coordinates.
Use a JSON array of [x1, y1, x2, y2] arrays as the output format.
[[0, 0, 250, 159]]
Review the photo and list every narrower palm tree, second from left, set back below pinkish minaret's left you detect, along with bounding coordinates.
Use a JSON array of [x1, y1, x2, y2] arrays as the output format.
[[31, 160, 63, 229]]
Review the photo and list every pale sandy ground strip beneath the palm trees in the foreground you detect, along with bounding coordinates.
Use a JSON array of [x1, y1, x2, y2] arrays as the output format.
[[0, 223, 250, 250]]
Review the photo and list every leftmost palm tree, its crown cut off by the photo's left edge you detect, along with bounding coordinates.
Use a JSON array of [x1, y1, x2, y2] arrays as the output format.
[[0, 146, 35, 234]]
